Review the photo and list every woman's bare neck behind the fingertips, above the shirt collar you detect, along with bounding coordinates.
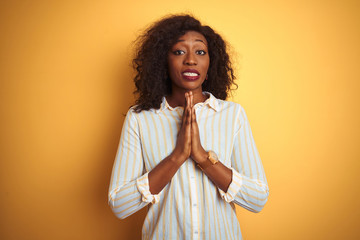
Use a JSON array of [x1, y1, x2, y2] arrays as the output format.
[[166, 88, 208, 108]]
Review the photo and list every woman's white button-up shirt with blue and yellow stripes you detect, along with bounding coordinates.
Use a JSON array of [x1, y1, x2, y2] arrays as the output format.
[[109, 93, 269, 240]]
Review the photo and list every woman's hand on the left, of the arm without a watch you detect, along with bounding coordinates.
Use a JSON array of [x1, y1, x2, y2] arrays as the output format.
[[172, 93, 192, 162]]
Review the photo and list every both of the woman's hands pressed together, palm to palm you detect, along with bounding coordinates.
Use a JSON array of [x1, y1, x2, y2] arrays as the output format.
[[173, 91, 207, 163]]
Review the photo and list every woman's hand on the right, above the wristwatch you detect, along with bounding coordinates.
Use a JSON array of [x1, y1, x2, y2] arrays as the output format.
[[189, 91, 208, 163]]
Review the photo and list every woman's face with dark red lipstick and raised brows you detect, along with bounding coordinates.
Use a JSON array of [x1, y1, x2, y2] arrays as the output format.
[[168, 31, 210, 92]]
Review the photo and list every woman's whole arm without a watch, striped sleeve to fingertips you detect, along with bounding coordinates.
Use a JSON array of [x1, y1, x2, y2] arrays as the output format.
[[109, 93, 191, 219]]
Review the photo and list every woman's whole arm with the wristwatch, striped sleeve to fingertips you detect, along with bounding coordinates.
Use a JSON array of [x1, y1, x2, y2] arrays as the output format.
[[192, 100, 269, 212]]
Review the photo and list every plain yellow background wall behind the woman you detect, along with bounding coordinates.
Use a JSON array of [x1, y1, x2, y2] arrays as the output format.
[[0, 0, 360, 240]]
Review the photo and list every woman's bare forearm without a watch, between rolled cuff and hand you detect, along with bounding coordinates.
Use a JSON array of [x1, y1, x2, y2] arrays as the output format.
[[148, 153, 186, 195]]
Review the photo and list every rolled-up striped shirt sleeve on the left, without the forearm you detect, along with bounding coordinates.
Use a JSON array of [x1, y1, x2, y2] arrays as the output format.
[[108, 109, 148, 219]]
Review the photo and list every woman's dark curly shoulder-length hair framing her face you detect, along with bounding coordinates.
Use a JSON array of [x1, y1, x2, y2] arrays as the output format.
[[133, 15, 237, 112]]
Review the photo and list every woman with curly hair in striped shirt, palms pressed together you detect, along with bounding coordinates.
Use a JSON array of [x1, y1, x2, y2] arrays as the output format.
[[109, 15, 269, 239]]
